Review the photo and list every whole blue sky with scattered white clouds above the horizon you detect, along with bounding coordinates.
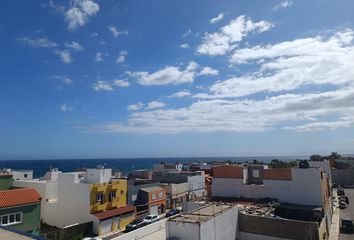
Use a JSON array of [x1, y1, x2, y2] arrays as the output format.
[[0, 0, 354, 159]]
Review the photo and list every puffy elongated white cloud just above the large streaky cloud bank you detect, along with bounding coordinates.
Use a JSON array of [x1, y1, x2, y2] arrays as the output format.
[[197, 16, 273, 56]]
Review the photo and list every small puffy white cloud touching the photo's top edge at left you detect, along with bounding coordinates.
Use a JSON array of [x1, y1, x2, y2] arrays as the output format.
[[65, 0, 100, 31]]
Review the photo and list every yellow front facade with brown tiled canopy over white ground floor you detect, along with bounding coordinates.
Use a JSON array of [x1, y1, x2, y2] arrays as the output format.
[[90, 179, 135, 235]]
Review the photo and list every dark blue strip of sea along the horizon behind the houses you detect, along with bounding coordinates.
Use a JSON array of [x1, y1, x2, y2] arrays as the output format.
[[0, 156, 304, 178]]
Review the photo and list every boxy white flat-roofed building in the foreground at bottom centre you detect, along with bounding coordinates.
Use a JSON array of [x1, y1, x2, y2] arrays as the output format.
[[167, 204, 238, 240]]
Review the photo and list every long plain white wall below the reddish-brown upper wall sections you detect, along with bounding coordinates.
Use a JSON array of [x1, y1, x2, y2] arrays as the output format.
[[212, 168, 323, 206]]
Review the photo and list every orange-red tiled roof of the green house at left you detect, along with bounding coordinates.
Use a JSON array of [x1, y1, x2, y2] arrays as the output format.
[[0, 188, 42, 208]]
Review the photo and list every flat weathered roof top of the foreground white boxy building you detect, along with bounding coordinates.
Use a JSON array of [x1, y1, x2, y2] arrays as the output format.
[[169, 204, 234, 224]]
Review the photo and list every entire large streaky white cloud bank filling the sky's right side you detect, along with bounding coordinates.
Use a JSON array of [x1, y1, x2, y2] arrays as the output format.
[[86, 29, 354, 134]]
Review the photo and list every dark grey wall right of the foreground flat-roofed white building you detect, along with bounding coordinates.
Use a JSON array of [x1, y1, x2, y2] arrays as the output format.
[[238, 213, 319, 240]]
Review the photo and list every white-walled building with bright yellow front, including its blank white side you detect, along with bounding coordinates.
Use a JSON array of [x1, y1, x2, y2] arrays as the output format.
[[14, 167, 135, 235]]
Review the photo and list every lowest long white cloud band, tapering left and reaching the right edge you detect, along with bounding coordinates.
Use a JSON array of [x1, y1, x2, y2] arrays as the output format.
[[81, 87, 354, 134]]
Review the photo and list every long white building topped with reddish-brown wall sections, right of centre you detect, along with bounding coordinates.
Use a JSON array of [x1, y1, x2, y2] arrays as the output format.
[[212, 165, 330, 206]]
